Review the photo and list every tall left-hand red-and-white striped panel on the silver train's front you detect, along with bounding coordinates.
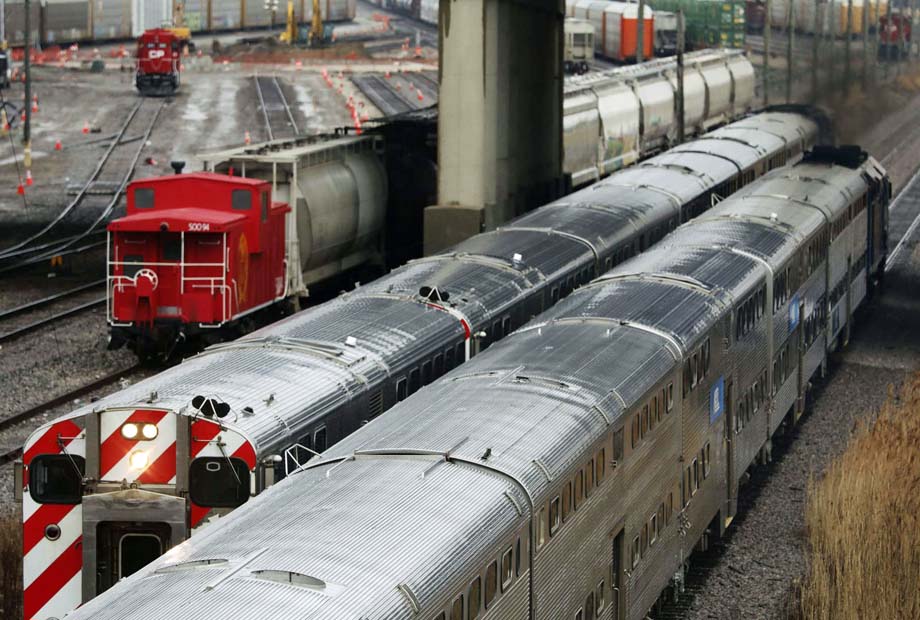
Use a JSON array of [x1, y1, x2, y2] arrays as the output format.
[[22, 420, 86, 620]]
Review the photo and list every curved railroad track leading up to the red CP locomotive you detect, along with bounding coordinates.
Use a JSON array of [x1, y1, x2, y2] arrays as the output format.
[[0, 98, 166, 273]]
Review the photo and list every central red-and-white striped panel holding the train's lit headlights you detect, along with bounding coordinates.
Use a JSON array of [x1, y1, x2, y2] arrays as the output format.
[[99, 409, 176, 484]]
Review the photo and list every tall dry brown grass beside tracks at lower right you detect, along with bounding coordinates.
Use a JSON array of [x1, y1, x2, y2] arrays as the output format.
[[800, 374, 920, 620]]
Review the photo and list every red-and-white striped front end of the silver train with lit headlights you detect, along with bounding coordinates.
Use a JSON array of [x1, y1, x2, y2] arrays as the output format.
[[17, 406, 259, 620]]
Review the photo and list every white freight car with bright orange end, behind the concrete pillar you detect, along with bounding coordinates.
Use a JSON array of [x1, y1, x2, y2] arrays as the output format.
[[566, 0, 655, 62]]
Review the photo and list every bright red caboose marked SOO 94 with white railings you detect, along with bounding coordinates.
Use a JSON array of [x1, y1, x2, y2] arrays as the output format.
[[107, 172, 290, 358]]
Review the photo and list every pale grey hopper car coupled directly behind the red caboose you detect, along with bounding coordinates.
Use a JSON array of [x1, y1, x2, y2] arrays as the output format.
[[197, 136, 387, 296]]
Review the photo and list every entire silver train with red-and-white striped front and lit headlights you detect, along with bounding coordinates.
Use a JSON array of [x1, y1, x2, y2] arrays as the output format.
[[16, 112, 819, 620]]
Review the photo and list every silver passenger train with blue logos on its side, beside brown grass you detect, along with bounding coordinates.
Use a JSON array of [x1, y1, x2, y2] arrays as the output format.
[[66, 144, 890, 620]]
